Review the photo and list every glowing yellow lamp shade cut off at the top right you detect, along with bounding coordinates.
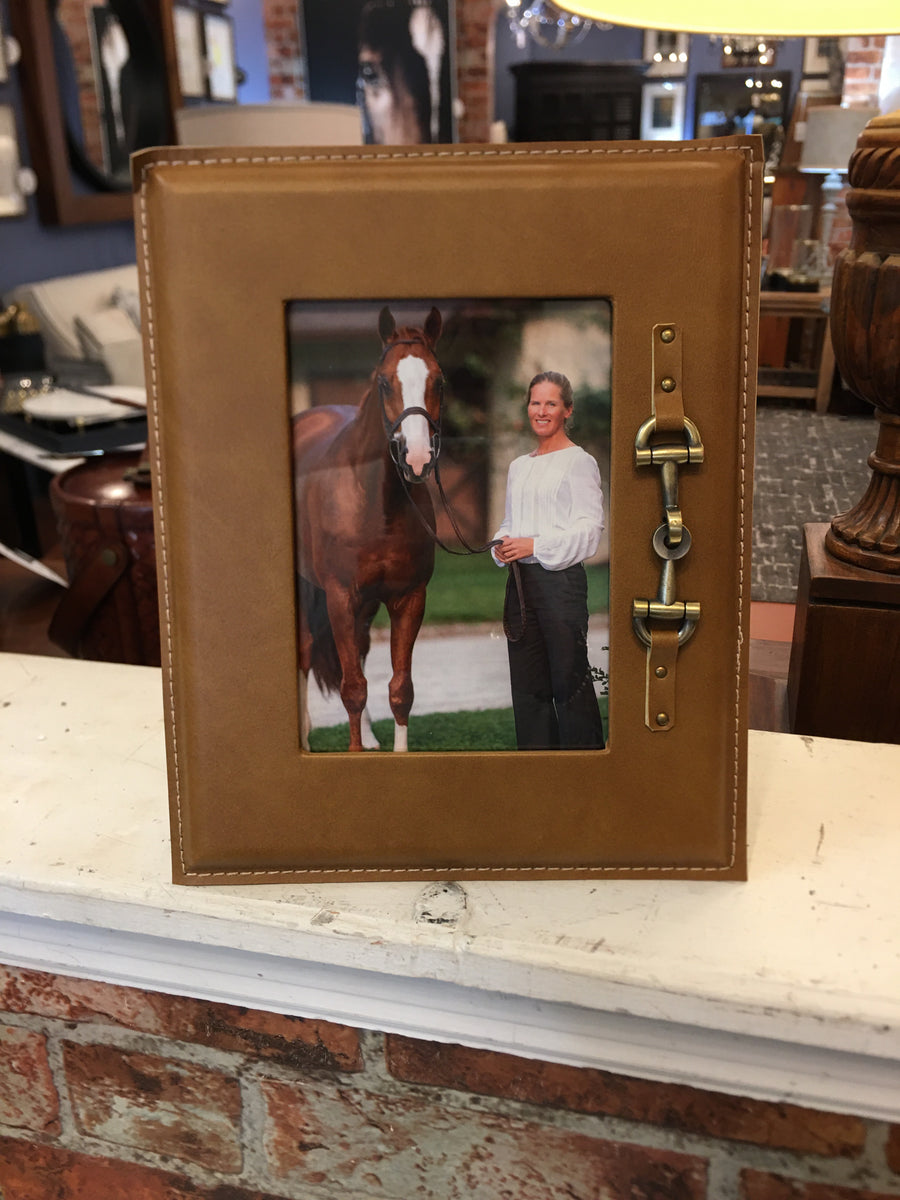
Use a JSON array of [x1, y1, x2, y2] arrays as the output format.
[[556, 0, 900, 37]]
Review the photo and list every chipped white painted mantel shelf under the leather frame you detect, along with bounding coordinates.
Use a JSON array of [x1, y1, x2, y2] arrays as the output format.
[[0, 654, 900, 1121]]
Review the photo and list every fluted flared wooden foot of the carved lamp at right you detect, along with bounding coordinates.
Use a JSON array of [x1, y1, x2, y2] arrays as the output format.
[[826, 412, 900, 574]]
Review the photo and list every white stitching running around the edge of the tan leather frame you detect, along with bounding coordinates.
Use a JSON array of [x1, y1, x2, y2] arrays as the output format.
[[140, 145, 755, 878]]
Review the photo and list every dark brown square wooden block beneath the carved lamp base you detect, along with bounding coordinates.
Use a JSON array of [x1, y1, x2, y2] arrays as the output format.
[[787, 523, 900, 743]]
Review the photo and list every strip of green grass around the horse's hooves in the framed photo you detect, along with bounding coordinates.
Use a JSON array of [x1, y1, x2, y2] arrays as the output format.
[[310, 696, 608, 754]]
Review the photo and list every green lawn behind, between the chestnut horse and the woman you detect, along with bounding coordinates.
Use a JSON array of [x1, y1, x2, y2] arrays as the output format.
[[374, 548, 610, 628]]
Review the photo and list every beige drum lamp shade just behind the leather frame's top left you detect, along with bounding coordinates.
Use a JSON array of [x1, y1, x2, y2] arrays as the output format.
[[175, 102, 362, 146]]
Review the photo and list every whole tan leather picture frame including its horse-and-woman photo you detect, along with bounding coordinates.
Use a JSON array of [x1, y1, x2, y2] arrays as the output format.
[[133, 137, 762, 883]]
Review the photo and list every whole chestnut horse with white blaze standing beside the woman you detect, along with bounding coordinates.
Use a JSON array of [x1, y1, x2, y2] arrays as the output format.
[[294, 307, 443, 750]]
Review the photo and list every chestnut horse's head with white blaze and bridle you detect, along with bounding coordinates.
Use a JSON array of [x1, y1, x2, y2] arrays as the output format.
[[376, 307, 444, 484]]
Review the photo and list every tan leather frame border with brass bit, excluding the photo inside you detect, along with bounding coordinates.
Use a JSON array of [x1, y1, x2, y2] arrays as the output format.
[[133, 137, 762, 884]]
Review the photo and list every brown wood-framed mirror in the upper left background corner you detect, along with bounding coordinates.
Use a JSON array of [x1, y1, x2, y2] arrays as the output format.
[[10, 0, 173, 224]]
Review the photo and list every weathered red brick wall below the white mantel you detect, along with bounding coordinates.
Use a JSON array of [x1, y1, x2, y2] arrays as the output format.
[[0, 967, 900, 1200]]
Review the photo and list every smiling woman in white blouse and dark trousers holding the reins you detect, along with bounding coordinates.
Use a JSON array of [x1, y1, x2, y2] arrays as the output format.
[[492, 371, 605, 750]]
